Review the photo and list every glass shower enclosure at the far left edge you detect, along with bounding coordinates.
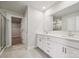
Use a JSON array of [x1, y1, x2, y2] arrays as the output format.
[[0, 14, 6, 51]]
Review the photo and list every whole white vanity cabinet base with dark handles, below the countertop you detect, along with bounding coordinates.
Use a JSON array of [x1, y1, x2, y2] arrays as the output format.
[[37, 35, 79, 58]]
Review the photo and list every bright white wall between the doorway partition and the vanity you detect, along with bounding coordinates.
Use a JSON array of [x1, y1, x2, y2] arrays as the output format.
[[28, 7, 43, 48]]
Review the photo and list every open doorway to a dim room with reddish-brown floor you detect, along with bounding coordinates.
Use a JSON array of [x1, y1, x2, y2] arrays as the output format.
[[12, 17, 22, 45]]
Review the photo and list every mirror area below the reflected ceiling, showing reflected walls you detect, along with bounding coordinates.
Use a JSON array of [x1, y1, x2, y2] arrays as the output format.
[[52, 11, 79, 32]]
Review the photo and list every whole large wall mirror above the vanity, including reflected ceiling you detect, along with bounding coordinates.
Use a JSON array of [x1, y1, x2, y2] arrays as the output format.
[[52, 3, 79, 32]]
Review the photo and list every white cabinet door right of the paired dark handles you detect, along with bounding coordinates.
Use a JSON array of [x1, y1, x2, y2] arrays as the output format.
[[66, 47, 79, 58]]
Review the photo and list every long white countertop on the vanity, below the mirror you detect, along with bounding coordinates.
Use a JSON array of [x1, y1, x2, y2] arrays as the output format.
[[37, 32, 79, 41]]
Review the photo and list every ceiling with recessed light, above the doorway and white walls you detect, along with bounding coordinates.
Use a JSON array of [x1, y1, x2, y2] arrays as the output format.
[[0, 1, 58, 14]]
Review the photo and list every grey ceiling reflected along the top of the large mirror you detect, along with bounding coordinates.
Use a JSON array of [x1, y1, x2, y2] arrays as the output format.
[[54, 2, 79, 16]]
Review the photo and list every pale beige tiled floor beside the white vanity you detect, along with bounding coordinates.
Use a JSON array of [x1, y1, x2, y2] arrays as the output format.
[[0, 45, 49, 58]]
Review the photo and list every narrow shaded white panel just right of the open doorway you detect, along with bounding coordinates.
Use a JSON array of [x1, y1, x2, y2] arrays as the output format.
[[21, 8, 28, 46]]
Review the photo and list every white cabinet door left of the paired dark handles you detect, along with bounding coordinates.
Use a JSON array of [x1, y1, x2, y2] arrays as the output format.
[[53, 43, 65, 58]]
